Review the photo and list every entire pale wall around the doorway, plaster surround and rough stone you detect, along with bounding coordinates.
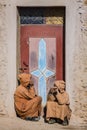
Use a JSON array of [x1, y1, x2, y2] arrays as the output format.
[[0, 0, 87, 125]]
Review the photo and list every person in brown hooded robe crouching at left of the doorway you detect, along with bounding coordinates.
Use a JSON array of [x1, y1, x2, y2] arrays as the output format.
[[14, 73, 42, 121]]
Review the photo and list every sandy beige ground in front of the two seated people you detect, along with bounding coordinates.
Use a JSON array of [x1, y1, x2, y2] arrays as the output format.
[[0, 117, 87, 130]]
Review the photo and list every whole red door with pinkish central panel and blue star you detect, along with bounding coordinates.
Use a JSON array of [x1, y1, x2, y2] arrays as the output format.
[[20, 25, 64, 103]]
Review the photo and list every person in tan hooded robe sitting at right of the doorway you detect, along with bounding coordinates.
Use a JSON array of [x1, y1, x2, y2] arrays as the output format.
[[46, 80, 71, 125]]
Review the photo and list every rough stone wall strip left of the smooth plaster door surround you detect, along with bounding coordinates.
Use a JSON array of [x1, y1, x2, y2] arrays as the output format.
[[0, 3, 8, 115]]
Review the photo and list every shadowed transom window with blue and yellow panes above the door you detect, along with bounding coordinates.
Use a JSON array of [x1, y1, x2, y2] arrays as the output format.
[[18, 7, 65, 25]]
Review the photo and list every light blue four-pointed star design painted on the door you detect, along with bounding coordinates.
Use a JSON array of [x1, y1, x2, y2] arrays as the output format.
[[31, 38, 55, 104]]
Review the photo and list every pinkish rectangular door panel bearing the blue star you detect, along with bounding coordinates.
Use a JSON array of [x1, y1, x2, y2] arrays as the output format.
[[29, 38, 56, 102]]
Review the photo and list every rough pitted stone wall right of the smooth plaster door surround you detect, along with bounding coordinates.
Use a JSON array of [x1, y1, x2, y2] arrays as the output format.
[[72, 0, 87, 124]]
